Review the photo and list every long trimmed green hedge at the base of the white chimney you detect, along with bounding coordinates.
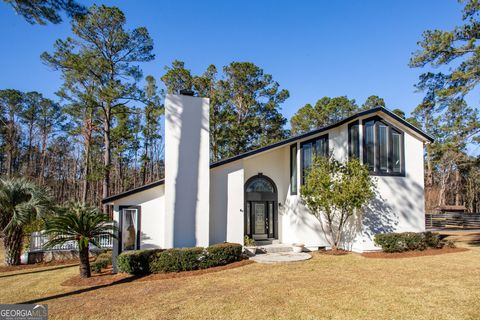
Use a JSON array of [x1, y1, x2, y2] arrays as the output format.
[[118, 243, 242, 274]]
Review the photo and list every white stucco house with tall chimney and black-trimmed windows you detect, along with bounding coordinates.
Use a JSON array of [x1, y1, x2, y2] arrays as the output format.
[[103, 95, 432, 253]]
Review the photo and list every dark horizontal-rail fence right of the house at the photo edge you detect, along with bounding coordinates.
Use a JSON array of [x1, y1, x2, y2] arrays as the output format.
[[425, 213, 480, 229]]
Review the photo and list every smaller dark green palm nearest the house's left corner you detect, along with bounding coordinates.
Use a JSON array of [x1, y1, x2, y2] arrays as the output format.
[[45, 204, 116, 278]]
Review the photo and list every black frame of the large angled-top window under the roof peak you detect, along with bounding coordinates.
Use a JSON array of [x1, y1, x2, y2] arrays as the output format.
[[362, 116, 405, 177]]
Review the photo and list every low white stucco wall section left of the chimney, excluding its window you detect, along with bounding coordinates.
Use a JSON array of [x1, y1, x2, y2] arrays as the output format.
[[113, 185, 165, 249]]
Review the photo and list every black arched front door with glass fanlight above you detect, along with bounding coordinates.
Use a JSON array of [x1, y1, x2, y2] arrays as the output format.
[[244, 174, 278, 239]]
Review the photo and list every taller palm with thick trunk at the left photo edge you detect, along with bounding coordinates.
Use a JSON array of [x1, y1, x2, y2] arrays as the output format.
[[0, 178, 51, 265]]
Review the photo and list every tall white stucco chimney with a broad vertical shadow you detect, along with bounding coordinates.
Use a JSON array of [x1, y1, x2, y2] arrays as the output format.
[[164, 94, 210, 247]]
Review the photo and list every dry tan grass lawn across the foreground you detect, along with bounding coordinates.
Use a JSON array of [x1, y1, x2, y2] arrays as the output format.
[[0, 242, 480, 319]]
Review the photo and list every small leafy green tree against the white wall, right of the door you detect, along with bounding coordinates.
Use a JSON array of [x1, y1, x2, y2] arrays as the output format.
[[301, 157, 375, 250]]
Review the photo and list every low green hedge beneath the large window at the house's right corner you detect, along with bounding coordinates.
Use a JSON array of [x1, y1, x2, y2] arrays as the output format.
[[374, 231, 446, 252]]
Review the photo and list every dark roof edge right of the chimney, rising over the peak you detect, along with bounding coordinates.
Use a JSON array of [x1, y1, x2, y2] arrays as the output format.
[[210, 107, 433, 169]]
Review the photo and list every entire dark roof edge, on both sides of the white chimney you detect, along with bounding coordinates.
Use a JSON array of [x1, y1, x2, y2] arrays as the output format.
[[102, 107, 433, 203]]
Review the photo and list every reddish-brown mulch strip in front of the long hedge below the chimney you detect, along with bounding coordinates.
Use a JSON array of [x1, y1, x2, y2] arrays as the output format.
[[62, 260, 255, 287]]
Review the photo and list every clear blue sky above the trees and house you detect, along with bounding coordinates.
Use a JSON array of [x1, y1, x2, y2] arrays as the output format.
[[0, 0, 462, 124]]
